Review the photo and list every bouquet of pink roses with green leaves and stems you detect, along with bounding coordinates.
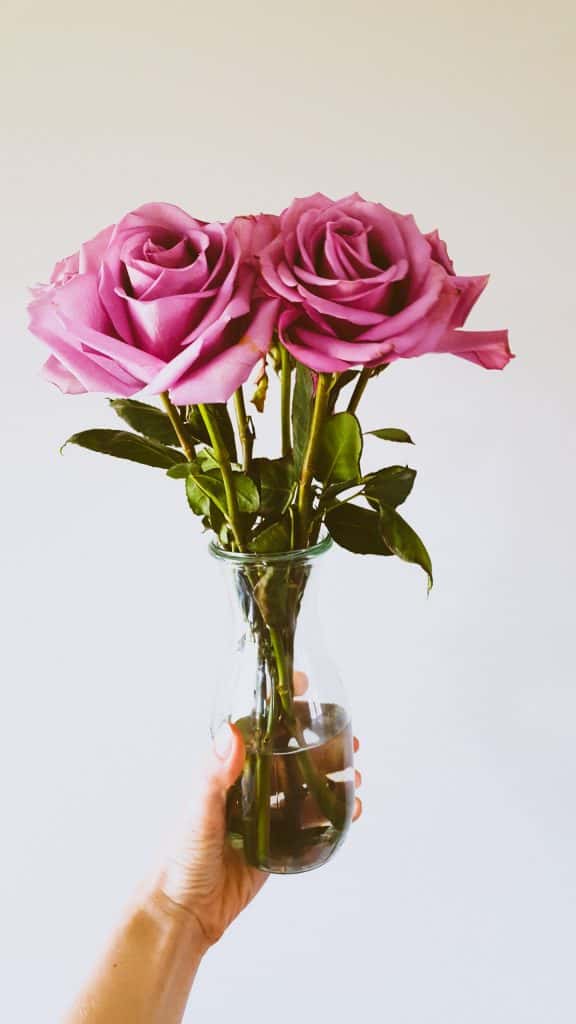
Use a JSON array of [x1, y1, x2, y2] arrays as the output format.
[[30, 194, 511, 863]]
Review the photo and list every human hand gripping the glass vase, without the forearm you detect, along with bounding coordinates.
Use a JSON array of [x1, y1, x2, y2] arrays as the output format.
[[152, 696, 362, 946]]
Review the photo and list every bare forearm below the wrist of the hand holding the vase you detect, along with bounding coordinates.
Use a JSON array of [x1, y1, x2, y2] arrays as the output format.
[[66, 888, 208, 1024]]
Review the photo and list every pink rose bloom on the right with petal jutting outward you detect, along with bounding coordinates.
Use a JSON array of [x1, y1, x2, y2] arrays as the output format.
[[260, 193, 511, 372]]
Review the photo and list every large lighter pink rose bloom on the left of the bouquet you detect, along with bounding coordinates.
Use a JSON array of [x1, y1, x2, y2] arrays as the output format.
[[30, 203, 279, 404]]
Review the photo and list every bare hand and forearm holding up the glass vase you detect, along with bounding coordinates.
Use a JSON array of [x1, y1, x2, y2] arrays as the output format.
[[65, 704, 362, 1024]]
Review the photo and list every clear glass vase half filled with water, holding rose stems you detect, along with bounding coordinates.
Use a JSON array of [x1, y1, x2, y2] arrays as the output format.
[[210, 537, 355, 873]]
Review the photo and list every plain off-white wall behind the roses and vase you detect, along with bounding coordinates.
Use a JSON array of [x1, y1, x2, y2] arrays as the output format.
[[0, 0, 576, 1024]]
